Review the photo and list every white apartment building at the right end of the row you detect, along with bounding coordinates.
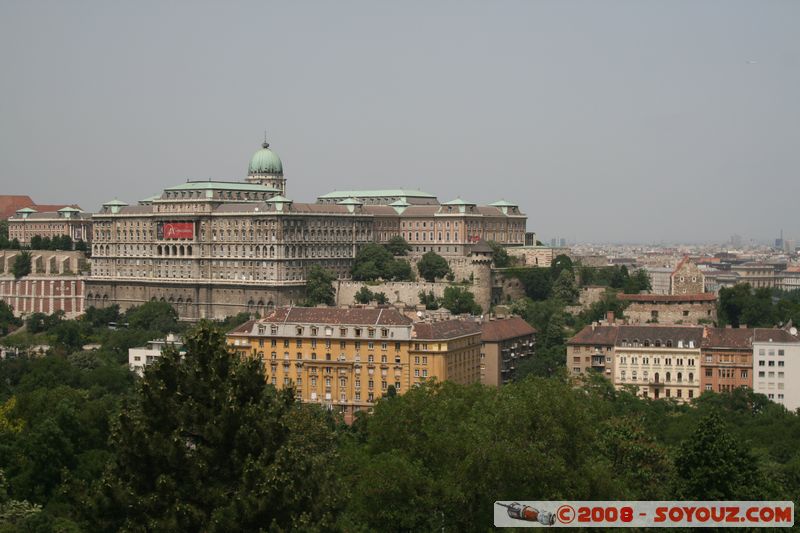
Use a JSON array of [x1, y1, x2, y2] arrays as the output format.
[[753, 328, 800, 411]]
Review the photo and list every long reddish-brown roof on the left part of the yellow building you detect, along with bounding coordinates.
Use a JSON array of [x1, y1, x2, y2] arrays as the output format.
[[260, 307, 412, 326]]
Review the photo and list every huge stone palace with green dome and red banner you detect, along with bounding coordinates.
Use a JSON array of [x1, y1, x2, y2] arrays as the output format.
[[86, 142, 527, 320]]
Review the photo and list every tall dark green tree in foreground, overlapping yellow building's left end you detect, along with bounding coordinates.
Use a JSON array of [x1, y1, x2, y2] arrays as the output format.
[[91, 325, 338, 532]]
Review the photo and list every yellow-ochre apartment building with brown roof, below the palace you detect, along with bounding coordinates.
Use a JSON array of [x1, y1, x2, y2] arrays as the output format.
[[227, 307, 481, 422]]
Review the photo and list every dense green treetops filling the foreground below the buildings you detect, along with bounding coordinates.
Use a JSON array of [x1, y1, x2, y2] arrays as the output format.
[[0, 308, 800, 532]]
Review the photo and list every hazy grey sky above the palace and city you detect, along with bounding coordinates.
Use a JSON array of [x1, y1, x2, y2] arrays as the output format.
[[0, 0, 800, 242]]
